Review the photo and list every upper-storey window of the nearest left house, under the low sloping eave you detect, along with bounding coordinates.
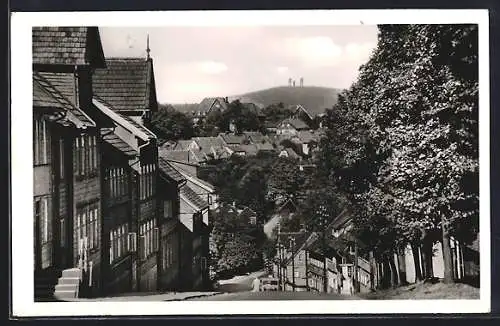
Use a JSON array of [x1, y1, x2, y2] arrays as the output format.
[[75, 135, 98, 176]]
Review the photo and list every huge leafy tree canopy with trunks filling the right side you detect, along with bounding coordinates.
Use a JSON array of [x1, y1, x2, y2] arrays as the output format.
[[319, 25, 478, 282]]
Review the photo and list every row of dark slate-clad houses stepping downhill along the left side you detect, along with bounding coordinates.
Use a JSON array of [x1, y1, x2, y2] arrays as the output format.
[[33, 27, 208, 300]]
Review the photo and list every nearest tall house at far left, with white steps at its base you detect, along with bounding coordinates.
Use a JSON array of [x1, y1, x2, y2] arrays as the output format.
[[32, 27, 105, 299]]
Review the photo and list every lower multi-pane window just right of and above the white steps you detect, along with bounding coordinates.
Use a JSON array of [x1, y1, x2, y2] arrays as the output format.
[[75, 203, 100, 250]]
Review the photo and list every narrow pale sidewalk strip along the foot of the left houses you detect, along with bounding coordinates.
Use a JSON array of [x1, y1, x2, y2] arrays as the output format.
[[62, 292, 223, 302]]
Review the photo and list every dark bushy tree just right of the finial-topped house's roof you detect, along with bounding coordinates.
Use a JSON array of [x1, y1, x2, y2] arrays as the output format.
[[148, 105, 194, 141]]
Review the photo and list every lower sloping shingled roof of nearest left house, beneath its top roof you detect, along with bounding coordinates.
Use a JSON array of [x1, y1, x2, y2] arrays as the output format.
[[33, 72, 95, 127]]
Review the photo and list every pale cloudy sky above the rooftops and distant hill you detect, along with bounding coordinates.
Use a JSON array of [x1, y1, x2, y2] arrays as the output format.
[[100, 25, 377, 103]]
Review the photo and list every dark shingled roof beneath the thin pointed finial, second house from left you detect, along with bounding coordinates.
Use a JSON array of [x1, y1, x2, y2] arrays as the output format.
[[92, 58, 157, 111]]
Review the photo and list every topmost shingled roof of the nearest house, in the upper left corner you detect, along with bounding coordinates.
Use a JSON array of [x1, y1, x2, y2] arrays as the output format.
[[32, 27, 106, 68]]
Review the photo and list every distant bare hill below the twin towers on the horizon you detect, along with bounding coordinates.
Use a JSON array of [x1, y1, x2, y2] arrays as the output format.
[[229, 86, 341, 114]]
